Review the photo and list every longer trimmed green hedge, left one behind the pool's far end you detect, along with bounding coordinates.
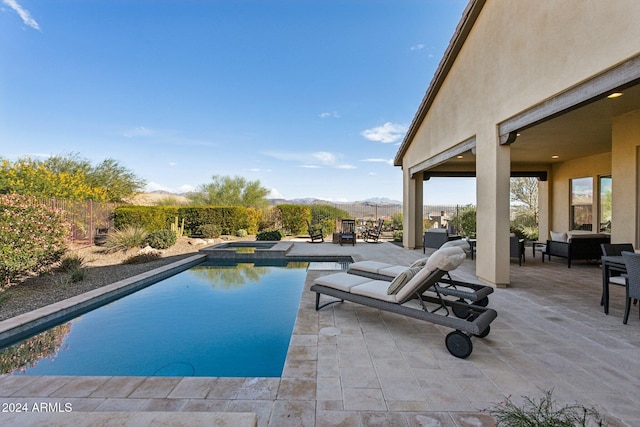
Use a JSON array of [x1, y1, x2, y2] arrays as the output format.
[[114, 206, 260, 235]]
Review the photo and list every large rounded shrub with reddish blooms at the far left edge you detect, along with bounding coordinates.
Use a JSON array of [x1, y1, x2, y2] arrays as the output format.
[[0, 194, 70, 285]]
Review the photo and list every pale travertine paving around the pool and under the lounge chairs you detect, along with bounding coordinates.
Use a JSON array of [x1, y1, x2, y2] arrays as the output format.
[[0, 242, 640, 427]]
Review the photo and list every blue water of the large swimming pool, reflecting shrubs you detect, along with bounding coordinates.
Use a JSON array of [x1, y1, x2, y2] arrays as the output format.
[[0, 262, 328, 377]]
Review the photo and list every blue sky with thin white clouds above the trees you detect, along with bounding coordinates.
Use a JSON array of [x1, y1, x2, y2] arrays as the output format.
[[0, 0, 475, 203]]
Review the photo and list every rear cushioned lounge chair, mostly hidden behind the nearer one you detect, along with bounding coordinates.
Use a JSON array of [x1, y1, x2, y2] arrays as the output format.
[[347, 254, 493, 308]]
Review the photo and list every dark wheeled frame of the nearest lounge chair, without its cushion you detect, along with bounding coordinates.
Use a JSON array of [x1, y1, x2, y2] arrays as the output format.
[[311, 269, 498, 359]]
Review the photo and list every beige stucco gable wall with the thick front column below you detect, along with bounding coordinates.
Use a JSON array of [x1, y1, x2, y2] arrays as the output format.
[[403, 0, 640, 285]]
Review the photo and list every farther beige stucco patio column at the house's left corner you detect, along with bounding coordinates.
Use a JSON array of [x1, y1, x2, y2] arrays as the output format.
[[402, 170, 423, 249]]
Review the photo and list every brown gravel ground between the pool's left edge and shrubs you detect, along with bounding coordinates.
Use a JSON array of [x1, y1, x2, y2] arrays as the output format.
[[0, 237, 216, 320]]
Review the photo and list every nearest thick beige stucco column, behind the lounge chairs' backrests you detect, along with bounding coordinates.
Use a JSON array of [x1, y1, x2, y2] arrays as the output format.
[[476, 123, 511, 287]]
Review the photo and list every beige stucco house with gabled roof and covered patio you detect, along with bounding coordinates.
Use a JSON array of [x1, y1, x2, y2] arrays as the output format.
[[394, 0, 640, 287]]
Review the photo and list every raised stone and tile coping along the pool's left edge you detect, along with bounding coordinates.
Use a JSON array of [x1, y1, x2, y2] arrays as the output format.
[[0, 253, 207, 348]]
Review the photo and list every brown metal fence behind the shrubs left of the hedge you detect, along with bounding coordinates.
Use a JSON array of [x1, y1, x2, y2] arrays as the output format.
[[36, 197, 119, 245]]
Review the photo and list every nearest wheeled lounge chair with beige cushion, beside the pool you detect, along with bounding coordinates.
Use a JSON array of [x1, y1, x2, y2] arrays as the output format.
[[311, 247, 498, 359]]
